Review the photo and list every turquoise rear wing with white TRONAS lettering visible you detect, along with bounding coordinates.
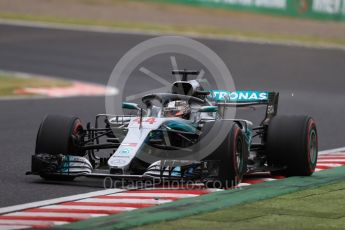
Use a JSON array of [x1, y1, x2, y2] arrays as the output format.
[[208, 90, 279, 125]]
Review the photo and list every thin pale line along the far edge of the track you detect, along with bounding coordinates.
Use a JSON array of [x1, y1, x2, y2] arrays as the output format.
[[0, 19, 345, 50]]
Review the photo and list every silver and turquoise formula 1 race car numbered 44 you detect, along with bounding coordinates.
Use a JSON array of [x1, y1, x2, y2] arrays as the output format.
[[28, 70, 318, 188]]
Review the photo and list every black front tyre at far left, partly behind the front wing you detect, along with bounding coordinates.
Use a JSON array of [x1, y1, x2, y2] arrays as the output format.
[[35, 115, 85, 181]]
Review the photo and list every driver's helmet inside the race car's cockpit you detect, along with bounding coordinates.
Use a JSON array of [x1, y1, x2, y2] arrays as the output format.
[[163, 101, 191, 119]]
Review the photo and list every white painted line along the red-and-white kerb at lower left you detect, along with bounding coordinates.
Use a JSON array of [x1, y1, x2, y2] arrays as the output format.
[[0, 189, 126, 214]]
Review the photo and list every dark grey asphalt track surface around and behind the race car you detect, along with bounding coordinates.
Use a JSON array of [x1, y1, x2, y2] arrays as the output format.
[[0, 25, 345, 207]]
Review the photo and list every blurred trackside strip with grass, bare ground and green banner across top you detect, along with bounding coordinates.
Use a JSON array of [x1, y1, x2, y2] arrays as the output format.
[[0, 0, 345, 45]]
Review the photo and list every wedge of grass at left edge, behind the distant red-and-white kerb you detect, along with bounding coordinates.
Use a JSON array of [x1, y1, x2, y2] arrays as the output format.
[[0, 73, 71, 96]]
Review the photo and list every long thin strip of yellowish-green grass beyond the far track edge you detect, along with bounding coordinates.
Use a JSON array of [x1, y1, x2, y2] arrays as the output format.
[[0, 12, 345, 46]]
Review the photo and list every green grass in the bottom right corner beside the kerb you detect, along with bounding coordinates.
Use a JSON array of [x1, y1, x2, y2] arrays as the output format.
[[134, 182, 345, 230]]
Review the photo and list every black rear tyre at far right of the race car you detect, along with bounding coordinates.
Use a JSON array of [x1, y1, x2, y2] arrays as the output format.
[[266, 116, 318, 176]]
